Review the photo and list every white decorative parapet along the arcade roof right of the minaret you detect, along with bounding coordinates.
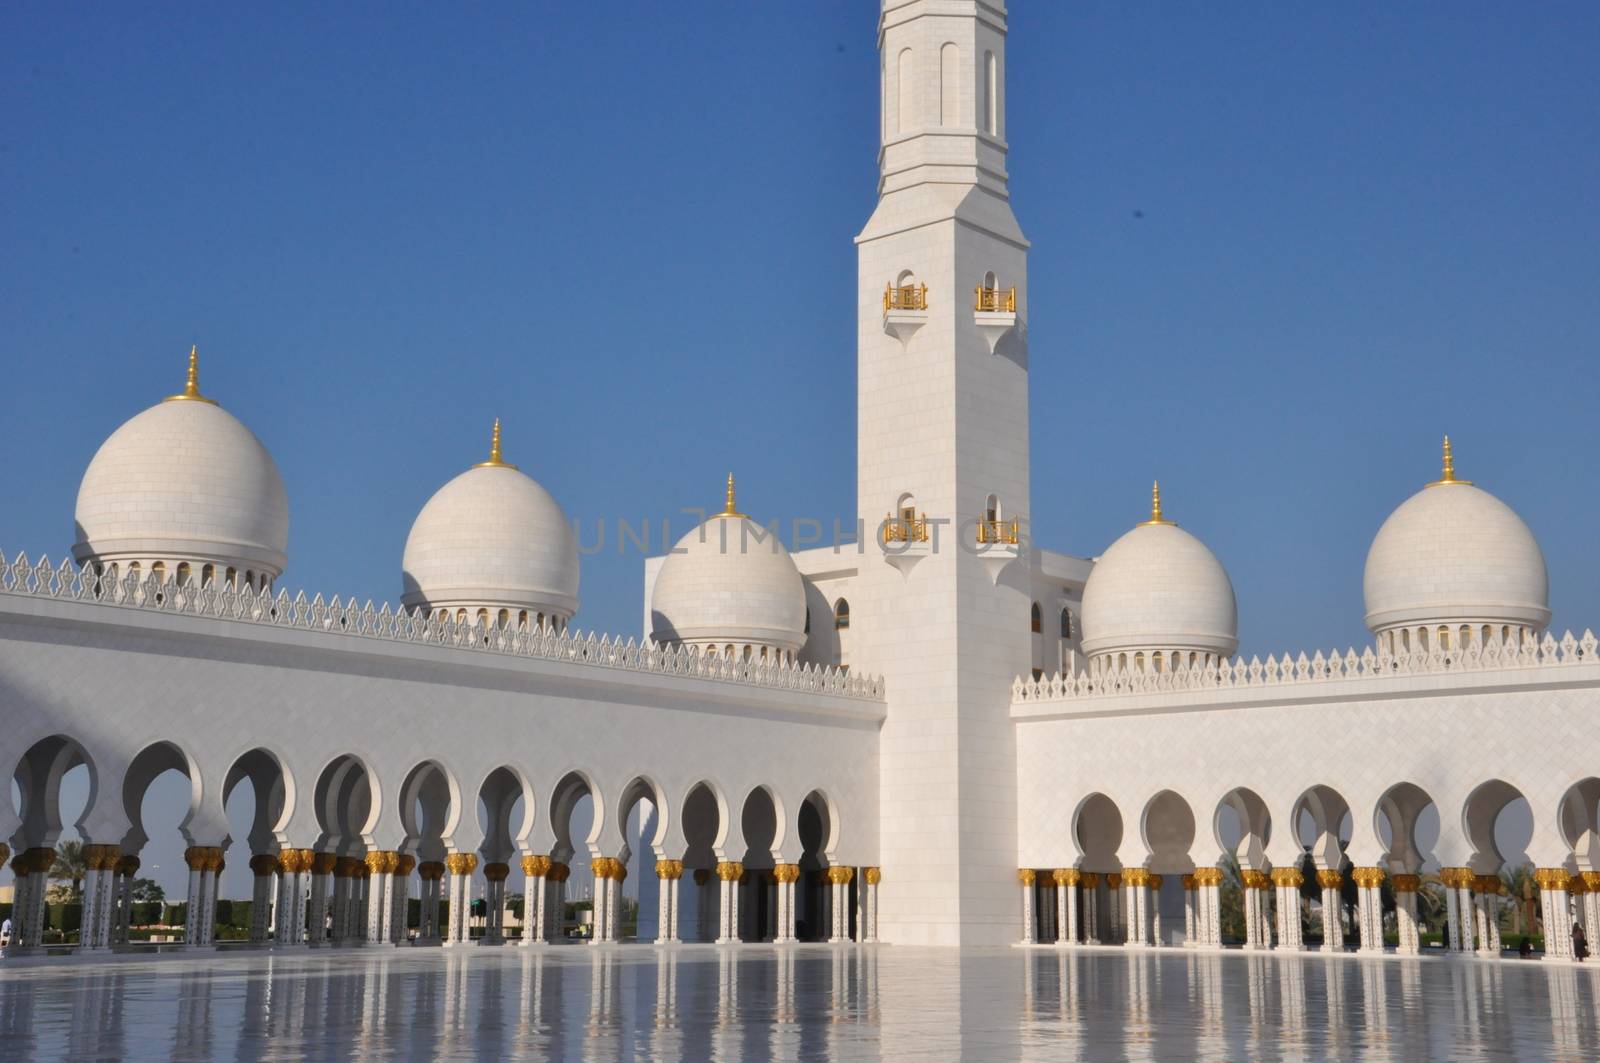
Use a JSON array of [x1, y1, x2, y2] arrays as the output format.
[[1011, 631, 1600, 703]]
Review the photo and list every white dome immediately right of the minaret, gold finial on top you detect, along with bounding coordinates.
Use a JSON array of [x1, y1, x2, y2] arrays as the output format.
[[1083, 487, 1238, 669]]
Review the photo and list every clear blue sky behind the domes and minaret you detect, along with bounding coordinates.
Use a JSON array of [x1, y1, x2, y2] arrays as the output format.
[[0, 0, 1600, 902]]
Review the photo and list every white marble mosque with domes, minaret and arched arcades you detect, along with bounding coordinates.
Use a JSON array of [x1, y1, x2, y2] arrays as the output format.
[[0, 0, 1600, 959]]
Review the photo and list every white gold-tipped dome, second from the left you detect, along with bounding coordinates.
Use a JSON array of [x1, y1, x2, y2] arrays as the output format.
[[400, 421, 578, 628]]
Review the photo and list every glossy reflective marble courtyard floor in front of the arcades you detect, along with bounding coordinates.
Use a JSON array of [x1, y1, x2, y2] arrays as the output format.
[[0, 946, 1600, 1061]]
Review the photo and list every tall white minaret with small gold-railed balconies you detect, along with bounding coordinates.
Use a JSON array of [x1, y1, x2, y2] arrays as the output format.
[[851, 0, 1032, 945]]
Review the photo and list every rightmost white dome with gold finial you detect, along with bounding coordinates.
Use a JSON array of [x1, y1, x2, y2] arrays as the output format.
[[1363, 437, 1550, 648]]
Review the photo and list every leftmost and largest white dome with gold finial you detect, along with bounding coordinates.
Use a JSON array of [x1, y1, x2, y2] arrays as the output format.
[[72, 351, 290, 584]]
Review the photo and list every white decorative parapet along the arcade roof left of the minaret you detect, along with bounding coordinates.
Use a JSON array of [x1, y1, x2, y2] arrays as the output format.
[[0, 552, 883, 701]]
